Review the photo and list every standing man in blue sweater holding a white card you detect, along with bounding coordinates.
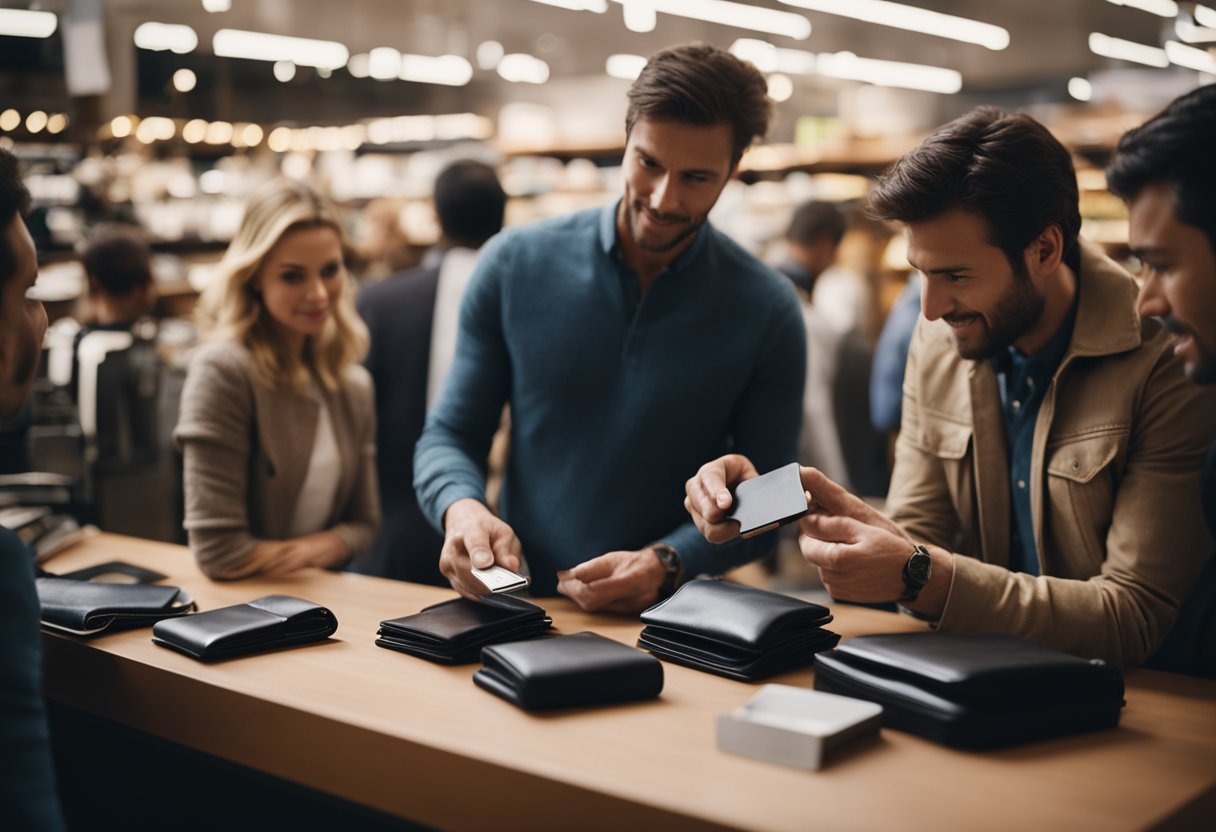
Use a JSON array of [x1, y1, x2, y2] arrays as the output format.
[[415, 45, 806, 612]]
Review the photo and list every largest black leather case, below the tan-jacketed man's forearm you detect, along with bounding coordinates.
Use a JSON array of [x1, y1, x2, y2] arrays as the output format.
[[815, 633, 1124, 748]]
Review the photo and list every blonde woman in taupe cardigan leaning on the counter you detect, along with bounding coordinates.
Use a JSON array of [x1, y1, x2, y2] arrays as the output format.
[[174, 181, 379, 579]]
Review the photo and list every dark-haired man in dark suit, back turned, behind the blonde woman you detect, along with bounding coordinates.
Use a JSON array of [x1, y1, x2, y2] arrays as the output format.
[[351, 159, 507, 586]]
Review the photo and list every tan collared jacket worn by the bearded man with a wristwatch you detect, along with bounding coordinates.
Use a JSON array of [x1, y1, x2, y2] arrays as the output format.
[[888, 242, 1216, 665]]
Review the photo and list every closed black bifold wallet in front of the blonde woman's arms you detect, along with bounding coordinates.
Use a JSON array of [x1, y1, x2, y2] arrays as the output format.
[[152, 595, 338, 660]]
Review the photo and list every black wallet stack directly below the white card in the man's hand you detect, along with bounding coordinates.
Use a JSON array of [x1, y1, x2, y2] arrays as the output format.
[[376, 595, 553, 664]]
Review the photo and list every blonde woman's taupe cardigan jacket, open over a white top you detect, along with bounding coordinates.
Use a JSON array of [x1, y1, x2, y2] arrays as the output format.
[[174, 341, 381, 578]]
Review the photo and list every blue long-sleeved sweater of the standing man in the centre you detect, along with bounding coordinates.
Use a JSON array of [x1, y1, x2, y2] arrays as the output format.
[[415, 203, 806, 595]]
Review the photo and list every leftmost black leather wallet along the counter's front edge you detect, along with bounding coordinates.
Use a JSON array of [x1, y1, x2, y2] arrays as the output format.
[[36, 578, 195, 635]]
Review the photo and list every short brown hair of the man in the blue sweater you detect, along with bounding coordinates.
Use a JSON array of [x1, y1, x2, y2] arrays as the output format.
[[625, 44, 772, 164]]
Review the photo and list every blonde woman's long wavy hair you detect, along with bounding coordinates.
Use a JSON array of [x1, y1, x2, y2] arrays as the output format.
[[196, 180, 367, 392]]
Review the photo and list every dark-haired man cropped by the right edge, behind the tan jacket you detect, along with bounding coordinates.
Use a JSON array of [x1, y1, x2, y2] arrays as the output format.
[[1107, 85, 1216, 678]]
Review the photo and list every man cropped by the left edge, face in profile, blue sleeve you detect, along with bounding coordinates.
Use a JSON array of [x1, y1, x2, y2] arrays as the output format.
[[0, 150, 63, 830]]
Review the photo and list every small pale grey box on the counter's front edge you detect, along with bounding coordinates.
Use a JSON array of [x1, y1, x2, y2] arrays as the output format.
[[717, 685, 883, 771]]
